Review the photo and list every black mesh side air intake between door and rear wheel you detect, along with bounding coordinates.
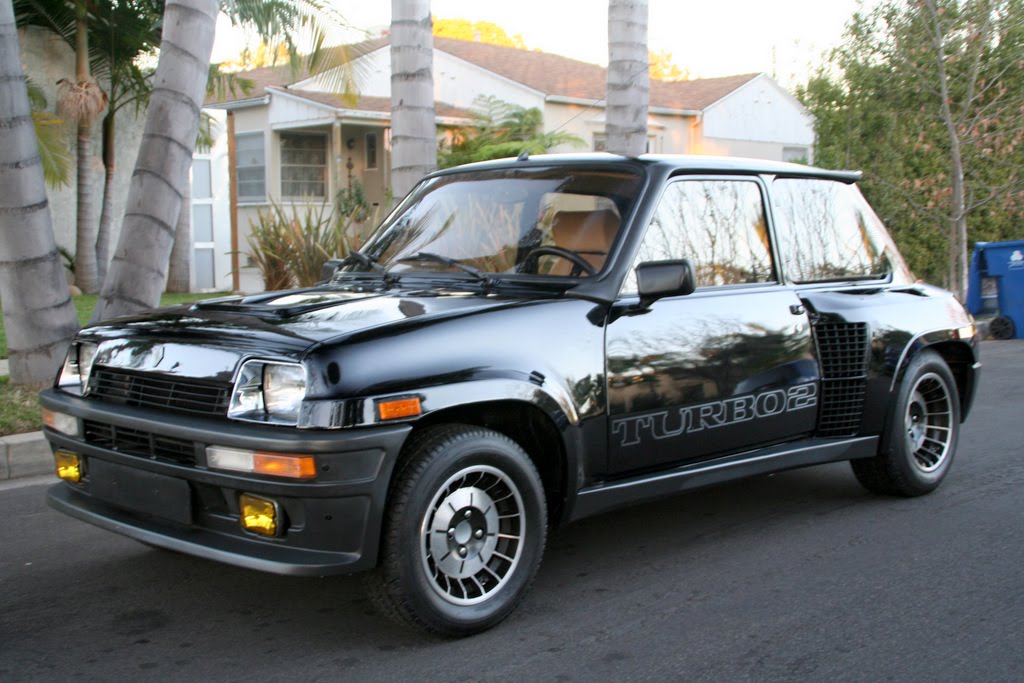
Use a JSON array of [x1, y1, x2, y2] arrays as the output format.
[[814, 321, 868, 436]]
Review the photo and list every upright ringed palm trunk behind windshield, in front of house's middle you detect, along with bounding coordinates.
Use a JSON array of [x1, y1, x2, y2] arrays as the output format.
[[391, 0, 437, 199]]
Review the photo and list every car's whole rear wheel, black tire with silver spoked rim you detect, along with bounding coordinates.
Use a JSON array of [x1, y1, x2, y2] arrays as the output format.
[[850, 351, 961, 497]]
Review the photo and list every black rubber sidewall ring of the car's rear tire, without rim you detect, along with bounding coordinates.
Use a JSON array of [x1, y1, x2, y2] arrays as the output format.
[[888, 351, 961, 494]]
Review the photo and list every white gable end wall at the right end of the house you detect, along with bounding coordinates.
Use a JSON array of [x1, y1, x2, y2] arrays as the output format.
[[702, 75, 814, 153]]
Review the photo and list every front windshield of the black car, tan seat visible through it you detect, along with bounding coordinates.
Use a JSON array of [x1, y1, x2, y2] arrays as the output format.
[[346, 167, 640, 279]]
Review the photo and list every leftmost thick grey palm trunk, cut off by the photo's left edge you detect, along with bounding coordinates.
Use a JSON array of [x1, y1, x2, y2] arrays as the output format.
[[0, 0, 78, 384]]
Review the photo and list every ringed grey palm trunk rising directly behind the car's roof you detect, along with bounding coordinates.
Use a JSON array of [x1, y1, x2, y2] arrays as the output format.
[[604, 0, 650, 157]]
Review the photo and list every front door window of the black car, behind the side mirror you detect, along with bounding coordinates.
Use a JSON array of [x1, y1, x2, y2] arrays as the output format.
[[623, 180, 775, 294]]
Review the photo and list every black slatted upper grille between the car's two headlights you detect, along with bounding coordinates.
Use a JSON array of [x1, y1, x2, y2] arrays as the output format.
[[89, 367, 231, 416]]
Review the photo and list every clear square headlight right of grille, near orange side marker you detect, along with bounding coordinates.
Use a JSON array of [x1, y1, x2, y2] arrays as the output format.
[[227, 360, 306, 425]]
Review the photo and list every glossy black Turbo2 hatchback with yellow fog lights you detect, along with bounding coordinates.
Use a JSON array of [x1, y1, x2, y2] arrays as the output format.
[[42, 155, 979, 635]]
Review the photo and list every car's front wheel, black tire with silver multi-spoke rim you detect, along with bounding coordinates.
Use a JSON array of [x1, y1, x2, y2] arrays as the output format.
[[367, 425, 548, 637]]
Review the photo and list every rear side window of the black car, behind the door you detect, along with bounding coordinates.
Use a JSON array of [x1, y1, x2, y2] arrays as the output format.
[[772, 178, 899, 283]]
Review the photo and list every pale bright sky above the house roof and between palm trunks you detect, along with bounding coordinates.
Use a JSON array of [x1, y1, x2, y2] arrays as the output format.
[[214, 0, 877, 87]]
